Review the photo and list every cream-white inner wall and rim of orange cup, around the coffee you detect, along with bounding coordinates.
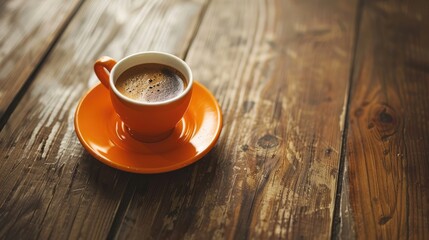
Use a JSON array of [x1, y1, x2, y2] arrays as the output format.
[[110, 52, 193, 105]]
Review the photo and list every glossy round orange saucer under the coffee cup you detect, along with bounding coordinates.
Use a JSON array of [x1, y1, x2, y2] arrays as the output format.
[[74, 82, 222, 173]]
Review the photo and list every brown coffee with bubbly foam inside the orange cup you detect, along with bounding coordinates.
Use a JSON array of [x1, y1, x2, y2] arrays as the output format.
[[115, 63, 187, 102]]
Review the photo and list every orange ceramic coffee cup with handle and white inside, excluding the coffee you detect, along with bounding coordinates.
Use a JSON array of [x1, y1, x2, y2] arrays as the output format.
[[94, 52, 193, 142]]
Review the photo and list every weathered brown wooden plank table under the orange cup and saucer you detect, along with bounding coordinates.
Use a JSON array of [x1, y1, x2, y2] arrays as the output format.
[[0, 0, 429, 239]]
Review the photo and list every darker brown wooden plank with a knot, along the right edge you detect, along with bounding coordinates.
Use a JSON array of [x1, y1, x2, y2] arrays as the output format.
[[342, 0, 429, 239]]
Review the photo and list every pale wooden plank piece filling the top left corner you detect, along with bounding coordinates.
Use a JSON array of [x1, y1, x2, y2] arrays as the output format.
[[0, 0, 81, 119]]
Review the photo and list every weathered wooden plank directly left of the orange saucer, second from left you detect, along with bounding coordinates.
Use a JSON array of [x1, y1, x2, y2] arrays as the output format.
[[0, 0, 207, 239]]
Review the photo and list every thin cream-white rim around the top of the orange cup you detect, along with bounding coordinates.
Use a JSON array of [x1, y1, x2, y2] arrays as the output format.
[[109, 51, 194, 106]]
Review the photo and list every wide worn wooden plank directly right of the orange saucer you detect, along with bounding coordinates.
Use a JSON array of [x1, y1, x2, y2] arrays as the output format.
[[113, 0, 357, 239]]
